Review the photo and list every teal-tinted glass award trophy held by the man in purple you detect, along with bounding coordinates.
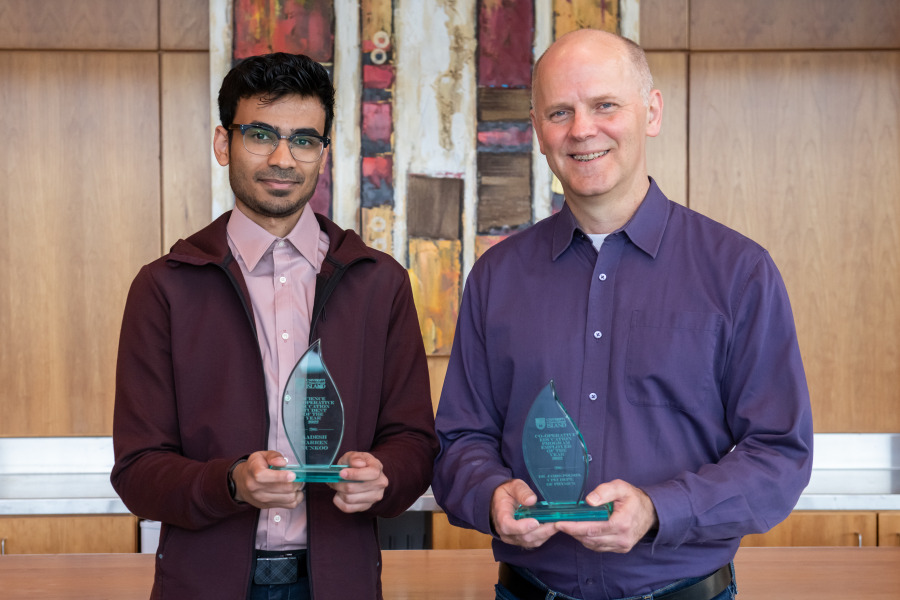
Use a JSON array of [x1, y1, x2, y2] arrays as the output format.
[[515, 379, 613, 523]]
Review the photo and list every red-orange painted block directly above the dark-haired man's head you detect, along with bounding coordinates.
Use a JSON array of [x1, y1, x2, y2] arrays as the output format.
[[234, 0, 334, 63]]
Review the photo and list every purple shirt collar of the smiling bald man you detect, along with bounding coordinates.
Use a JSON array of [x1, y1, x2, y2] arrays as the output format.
[[551, 177, 669, 260]]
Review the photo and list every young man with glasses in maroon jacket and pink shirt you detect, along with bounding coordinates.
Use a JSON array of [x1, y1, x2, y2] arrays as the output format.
[[111, 53, 437, 600]]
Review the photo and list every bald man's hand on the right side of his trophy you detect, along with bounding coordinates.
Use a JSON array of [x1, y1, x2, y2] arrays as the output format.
[[556, 479, 657, 554]]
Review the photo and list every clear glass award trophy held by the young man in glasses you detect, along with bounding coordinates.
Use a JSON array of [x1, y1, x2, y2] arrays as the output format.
[[270, 340, 348, 482]]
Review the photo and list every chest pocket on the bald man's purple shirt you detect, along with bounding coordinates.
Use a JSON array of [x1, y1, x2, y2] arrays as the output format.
[[625, 311, 724, 412]]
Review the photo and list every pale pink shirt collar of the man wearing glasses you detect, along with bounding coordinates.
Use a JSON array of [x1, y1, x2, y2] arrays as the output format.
[[228, 205, 321, 272]]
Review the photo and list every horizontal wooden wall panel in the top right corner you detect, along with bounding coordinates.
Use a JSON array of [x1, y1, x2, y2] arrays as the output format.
[[688, 0, 900, 50]]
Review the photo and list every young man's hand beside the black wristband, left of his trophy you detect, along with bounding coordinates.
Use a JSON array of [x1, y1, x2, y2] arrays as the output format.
[[231, 450, 303, 509]]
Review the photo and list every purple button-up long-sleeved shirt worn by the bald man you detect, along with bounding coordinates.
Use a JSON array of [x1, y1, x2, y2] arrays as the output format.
[[433, 180, 812, 600]]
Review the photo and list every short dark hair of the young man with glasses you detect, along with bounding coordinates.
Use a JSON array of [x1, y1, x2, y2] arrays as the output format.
[[219, 52, 334, 135]]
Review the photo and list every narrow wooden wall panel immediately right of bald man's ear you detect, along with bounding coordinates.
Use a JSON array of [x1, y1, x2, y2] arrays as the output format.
[[647, 52, 688, 204]]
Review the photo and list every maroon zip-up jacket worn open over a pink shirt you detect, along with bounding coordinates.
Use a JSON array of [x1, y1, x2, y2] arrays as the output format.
[[111, 213, 437, 600]]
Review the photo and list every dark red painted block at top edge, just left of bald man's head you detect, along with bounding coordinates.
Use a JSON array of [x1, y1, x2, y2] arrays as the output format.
[[478, 0, 534, 87]]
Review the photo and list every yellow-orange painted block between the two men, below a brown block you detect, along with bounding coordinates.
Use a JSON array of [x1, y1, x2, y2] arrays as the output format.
[[409, 238, 462, 354]]
